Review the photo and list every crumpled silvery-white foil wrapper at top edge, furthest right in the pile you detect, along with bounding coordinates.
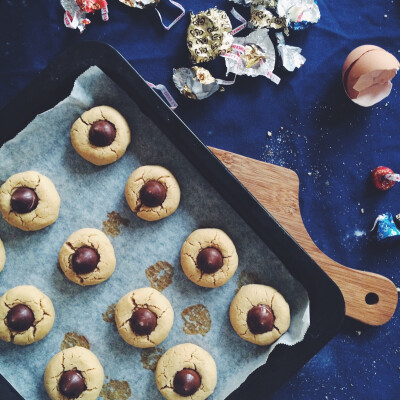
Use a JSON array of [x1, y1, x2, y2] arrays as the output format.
[[276, 0, 321, 30]]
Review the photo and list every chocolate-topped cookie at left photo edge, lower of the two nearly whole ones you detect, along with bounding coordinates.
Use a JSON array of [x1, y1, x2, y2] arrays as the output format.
[[0, 285, 55, 346]]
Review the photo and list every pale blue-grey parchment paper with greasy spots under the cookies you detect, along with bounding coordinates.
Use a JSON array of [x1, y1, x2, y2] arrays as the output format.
[[0, 67, 309, 400]]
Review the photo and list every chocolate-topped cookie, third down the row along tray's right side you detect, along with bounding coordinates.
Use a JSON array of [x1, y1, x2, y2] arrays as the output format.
[[181, 228, 239, 288]]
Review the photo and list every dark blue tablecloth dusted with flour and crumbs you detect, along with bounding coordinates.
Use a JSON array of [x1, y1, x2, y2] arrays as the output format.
[[0, 0, 400, 400]]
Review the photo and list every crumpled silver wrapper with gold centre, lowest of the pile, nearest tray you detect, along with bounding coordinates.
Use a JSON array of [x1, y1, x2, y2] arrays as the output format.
[[172, 67, 220, 100]]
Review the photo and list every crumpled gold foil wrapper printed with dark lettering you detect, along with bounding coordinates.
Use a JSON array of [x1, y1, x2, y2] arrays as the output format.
[[187, 7, 233, 64]]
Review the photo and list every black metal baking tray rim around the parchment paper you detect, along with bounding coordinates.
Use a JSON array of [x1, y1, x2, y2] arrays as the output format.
[[0, 42, 345, 400]]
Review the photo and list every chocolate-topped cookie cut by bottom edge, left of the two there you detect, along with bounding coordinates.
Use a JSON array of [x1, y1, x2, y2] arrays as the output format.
[[44, 346, 104, 400]]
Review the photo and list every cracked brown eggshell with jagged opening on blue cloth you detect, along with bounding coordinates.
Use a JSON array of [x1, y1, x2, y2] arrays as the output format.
[[342, 45, 400, 107]]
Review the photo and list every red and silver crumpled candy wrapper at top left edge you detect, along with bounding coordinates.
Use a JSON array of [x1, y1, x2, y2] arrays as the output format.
[[61, 0, 109, 33]]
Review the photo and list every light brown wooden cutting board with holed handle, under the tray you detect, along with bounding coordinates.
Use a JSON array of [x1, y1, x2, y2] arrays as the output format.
[[210, 147, 398, 325]]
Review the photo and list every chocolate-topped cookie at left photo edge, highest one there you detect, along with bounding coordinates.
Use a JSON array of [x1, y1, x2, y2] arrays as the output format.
[[0, 171, 60, 231]]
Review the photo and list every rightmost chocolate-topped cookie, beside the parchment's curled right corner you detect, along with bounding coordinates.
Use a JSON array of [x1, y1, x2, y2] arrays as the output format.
[[229, 285, 290, 346]]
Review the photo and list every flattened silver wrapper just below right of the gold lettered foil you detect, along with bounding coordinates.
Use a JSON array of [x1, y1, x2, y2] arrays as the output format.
[[225, 28, 275, 77]]
